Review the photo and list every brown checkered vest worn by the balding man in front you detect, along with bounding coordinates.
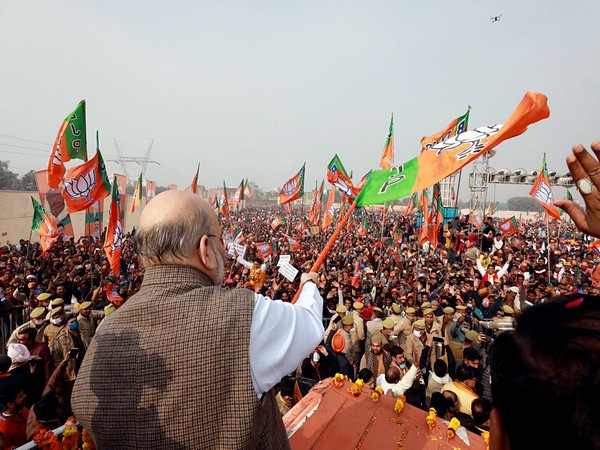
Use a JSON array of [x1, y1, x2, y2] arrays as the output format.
[[72, 265, 289, 450]]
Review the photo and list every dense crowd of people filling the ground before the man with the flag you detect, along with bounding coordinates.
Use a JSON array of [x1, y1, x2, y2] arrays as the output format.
[[0, 157, 600, 448]]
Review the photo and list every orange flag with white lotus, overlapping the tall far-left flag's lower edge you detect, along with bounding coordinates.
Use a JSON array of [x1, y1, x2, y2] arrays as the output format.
[[61, 150, 110, 213]]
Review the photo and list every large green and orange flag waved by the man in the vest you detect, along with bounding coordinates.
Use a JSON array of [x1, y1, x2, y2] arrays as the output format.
[[357, 92, 550, 206]]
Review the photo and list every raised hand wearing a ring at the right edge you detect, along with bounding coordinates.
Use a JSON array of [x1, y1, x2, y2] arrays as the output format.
[[554, 141, 600, 238]]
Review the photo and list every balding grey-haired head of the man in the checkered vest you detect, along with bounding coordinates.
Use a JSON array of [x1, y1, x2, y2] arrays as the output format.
[[136, 191, 221, 272]]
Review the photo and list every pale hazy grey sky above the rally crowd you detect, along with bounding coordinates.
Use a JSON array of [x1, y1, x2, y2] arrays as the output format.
[[0, 0, 600, 200]]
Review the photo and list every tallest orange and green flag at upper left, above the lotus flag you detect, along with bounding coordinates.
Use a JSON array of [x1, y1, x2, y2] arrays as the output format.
[[46, 100, 87, 189]]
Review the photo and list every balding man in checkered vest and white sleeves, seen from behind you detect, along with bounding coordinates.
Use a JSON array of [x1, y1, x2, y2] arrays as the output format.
[[73, 191, 324, 449]]
